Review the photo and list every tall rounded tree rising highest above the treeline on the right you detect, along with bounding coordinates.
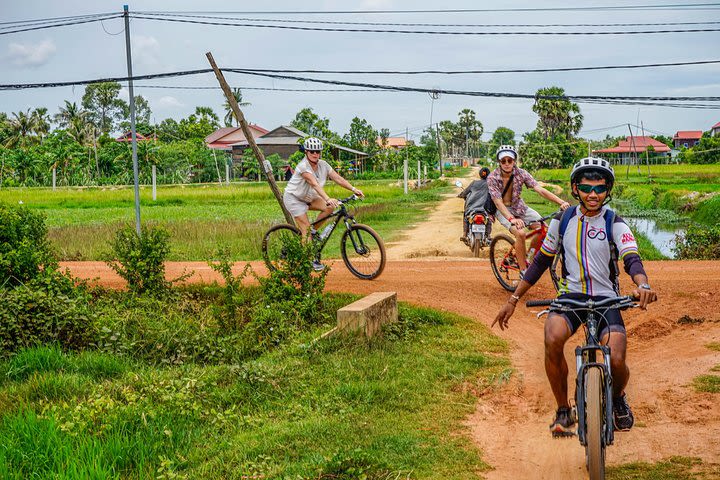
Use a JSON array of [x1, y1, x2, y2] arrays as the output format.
[[532, 87, 583, 140]]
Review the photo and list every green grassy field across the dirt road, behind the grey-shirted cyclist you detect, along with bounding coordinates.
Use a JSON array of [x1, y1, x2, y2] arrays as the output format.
[[0, 180, 450, 260]]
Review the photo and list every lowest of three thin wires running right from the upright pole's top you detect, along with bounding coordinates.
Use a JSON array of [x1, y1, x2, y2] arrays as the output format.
[[131, 14, 720, 36]]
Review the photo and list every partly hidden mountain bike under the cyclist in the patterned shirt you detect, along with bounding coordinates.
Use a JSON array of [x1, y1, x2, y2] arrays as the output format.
[[490, 212, 561, 292]]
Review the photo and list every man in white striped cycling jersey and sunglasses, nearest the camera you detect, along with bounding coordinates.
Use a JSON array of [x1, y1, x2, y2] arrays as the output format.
[[492, 157, 657, 436]]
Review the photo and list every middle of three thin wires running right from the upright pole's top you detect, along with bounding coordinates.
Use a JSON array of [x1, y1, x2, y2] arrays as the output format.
[[136, 12, 720, 28]]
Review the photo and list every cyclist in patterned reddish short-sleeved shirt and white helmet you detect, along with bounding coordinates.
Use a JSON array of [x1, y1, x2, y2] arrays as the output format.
[[488, 145, 570, 274]]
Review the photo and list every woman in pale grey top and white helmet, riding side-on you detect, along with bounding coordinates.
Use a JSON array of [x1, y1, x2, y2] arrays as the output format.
[[283, 137, 364, 271]]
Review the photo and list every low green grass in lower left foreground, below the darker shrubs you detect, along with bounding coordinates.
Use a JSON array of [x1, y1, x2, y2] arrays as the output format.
[[0, 295, 509, 479]]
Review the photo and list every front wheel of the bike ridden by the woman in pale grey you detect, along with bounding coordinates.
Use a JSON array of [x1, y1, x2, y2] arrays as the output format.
[[340, 223, 386, 280]]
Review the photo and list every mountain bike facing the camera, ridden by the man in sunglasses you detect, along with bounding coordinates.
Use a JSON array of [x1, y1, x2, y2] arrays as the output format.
[[526, 296, 638, 480]]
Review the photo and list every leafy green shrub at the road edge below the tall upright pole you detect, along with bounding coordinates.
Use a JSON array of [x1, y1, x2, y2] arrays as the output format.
[[105, 225, 170, 294]]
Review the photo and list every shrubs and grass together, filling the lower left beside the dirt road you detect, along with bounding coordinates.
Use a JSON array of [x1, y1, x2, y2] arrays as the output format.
[[0, 202, 510, 479]]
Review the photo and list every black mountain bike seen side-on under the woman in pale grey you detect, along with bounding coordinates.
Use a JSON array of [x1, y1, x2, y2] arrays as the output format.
[[262, 195, 386, 280]]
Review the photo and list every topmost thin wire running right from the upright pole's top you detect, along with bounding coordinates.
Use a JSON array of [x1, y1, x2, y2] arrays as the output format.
[[136, 3, 720, 15]]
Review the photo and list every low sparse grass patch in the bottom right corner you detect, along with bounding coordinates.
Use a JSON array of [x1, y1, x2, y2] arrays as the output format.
[[606, 457, 720, 480]]
